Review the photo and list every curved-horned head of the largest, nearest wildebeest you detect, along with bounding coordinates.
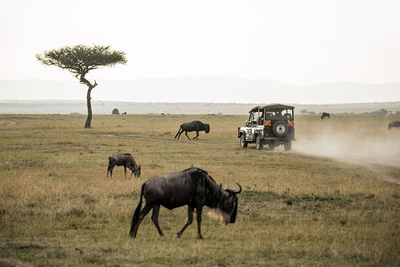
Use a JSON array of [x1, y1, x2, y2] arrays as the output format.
[[213, 183, 242, 224]]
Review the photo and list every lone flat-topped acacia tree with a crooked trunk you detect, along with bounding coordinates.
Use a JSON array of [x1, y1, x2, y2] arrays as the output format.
[[36, 45, 128, 128]]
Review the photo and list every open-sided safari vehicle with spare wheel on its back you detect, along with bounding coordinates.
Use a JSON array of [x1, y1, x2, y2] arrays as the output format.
[[238, 104, 295, 151]]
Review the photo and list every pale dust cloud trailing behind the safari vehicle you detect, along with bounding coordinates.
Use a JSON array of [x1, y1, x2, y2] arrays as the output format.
[[293, 119, 400, 176]]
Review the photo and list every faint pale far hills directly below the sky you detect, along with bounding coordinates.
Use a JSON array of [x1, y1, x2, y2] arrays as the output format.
[[0, 76, 400, 104]]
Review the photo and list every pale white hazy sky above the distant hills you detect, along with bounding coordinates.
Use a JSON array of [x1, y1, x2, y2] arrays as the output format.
[[0, 0, 400, 86]]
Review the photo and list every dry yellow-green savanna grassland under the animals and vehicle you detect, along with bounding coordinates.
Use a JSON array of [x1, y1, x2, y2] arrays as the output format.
[[0, 115, 400, 266]]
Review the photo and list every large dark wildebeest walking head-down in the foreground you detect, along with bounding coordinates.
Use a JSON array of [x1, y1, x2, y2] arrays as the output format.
[[129, 168, 242, 238]]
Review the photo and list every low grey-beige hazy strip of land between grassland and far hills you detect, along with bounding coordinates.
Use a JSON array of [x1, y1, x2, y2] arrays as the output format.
[[0, 99, 400, 114]]
